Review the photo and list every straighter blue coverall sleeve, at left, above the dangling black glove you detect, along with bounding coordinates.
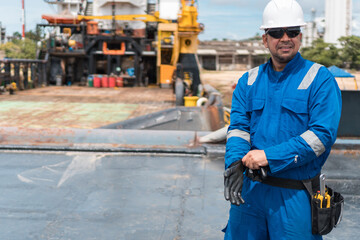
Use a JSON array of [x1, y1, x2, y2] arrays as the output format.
[[225, 73, 250, 169]]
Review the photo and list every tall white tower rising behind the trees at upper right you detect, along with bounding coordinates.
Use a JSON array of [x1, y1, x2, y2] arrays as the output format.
[[324, 0, 352, 44]]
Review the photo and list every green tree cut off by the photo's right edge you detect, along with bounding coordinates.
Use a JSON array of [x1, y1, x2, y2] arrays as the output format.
[[339, 36, 360, 70]]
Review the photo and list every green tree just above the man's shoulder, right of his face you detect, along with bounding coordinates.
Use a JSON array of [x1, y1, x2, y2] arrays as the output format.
[[301, 38, 343, 67]]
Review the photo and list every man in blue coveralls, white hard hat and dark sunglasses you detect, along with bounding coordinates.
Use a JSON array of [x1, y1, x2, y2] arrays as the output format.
[[224, 0, 341, 240]]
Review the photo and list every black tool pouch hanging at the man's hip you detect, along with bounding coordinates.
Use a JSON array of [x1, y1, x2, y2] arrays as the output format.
[[311, 187, 344, 235]]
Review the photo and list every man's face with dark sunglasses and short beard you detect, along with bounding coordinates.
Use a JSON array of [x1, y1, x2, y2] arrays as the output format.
[[262, 27, 302, 64]]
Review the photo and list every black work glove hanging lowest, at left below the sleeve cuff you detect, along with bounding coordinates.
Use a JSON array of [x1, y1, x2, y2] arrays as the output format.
[[224, 160, 245, 206]]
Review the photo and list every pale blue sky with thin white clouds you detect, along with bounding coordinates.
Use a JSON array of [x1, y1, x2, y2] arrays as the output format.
[[0, 0, 360, 40]]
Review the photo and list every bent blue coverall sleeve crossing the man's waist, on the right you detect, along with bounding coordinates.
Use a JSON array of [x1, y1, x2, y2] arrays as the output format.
[[264, 67, 342, 173]]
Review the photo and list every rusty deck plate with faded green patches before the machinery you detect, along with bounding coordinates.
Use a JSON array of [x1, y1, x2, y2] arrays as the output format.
[[0, 86, 174, 129]]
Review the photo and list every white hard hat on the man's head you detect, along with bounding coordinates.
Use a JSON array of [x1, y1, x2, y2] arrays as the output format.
[[260, 0, 306, 30]]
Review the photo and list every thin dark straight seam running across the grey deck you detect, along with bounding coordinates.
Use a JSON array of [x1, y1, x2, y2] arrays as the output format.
[[0, 145, 207, 155]]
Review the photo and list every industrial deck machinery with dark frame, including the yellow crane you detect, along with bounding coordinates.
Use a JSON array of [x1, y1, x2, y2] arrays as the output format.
[[37, 0, 203, 105]]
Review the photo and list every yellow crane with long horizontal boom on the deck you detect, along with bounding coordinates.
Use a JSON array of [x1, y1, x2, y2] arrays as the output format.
[[77, 0, 204, 105]]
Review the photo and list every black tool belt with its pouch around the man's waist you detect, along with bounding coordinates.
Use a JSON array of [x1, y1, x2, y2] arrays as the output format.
[[245, 169, 344, 235]]
